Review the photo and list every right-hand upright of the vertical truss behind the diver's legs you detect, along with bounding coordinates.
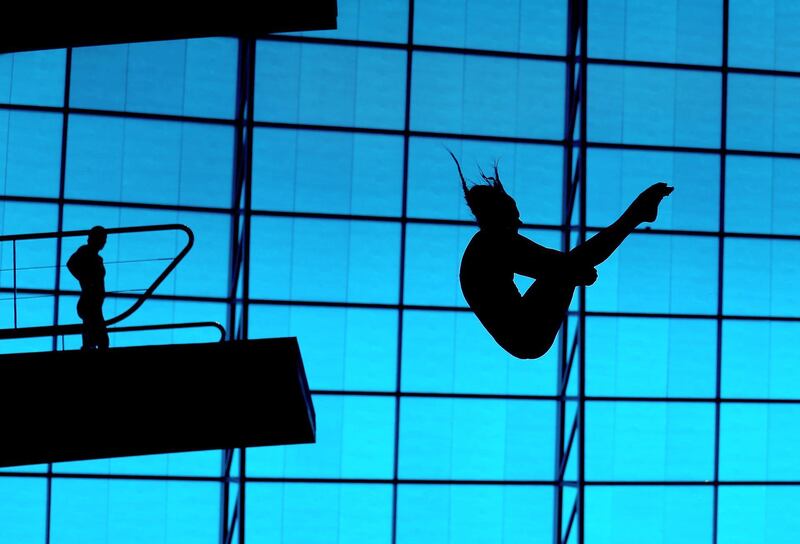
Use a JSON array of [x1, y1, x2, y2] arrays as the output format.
[[577, 0, 589, 544]]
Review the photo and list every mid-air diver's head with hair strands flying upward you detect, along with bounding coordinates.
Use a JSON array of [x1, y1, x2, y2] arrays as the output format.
[[450, 151, 522, 232]]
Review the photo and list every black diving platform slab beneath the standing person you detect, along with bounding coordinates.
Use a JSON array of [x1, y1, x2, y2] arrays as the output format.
[[0, 338, 316, 467]]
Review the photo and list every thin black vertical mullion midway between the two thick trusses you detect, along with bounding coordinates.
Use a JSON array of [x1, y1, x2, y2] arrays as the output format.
[[392, 0, 414, 544]]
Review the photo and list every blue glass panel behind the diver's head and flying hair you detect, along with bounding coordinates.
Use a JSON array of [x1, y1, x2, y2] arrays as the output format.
[[408, 138, 564, 225]]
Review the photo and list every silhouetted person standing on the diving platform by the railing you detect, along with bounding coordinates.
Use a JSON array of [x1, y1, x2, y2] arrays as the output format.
[[67, 226, 108, 350]]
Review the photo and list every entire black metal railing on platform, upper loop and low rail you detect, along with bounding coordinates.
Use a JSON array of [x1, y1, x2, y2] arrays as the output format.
[[0, 223, 226, 341]]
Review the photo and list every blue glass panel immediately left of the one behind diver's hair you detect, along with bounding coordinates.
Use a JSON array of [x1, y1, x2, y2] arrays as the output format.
[[253, 129, 403, 216]]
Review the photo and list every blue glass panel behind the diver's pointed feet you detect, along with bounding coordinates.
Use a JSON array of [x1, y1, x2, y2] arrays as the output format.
[[586, 149, 727, 230]]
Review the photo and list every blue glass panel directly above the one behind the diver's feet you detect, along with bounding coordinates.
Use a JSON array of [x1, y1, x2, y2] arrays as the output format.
[[587, 65, 731, 147]]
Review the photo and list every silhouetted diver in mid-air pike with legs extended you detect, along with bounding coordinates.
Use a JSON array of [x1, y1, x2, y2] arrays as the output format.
[[448, 150, 673, 359]]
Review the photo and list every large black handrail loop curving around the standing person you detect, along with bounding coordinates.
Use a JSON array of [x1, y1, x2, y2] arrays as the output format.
[[0, 223, 194, 340]]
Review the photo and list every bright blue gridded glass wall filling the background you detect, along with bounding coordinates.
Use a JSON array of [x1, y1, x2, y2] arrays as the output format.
[[0, 0, 800, 544]]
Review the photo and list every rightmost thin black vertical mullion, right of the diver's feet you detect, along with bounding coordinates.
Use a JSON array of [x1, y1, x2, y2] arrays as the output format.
[[712, 0, 729, 544]]
